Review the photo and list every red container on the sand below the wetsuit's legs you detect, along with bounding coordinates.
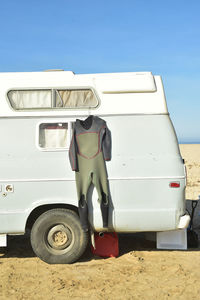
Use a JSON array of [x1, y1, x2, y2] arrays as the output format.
[[91, 232, 119, 257]]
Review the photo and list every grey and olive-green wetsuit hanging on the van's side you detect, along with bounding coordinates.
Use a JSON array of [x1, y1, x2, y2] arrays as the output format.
[[69, 116, 111, 231]]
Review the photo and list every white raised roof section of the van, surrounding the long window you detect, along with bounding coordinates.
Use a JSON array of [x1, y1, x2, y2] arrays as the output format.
[[0, 70, 167, 116]]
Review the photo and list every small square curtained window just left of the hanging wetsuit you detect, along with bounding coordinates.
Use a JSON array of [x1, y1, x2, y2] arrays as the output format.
[[39, 123, 68, 149]]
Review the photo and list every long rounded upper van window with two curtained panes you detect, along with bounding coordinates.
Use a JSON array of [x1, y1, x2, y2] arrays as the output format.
[[8, 89, 98, 110]]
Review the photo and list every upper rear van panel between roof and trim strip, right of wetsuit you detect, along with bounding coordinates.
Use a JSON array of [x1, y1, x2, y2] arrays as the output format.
[[104, 115, 184, 178]]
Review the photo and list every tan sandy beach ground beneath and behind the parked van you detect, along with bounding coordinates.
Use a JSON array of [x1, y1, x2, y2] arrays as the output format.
[[0, 145, 200, 300]]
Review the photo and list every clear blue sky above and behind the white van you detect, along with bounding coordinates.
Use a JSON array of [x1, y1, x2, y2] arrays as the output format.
[[0, 0, 200, 143]]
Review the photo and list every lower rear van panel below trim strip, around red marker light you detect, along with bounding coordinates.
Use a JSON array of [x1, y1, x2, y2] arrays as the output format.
[[111, 179, 185, 232]]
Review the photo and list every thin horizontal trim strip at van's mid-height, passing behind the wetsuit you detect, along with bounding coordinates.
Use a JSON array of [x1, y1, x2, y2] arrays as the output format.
[[0, 176, 185, 183]]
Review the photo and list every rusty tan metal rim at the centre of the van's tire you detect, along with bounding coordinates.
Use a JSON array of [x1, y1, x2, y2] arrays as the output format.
[[46, 224, 74, 255]]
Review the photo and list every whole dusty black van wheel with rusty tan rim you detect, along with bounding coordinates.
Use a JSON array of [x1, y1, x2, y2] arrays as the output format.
[[31, 208, 88, 264]]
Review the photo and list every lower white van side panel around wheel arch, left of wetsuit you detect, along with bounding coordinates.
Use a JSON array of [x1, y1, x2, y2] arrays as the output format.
[[0, 180, 77, 233]]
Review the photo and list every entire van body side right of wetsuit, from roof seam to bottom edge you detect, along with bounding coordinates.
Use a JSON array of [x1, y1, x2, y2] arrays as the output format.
[[106, 115, 185, 231]]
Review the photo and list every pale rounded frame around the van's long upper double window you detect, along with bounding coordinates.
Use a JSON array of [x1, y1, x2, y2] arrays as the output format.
[[6, 86, 100, 112]]
